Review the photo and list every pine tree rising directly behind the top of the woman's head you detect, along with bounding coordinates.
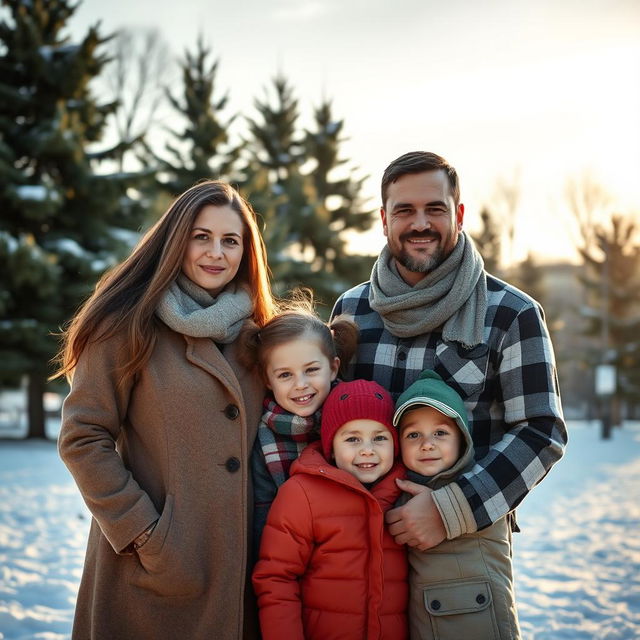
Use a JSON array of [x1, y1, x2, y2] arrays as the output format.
[[160, 38, 238, 196]]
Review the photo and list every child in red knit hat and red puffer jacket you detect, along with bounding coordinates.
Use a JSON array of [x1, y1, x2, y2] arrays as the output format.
[[253, 380, 408, 640]]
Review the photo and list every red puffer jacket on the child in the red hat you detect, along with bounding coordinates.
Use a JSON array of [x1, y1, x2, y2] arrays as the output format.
[[253, 442, 408, 640]]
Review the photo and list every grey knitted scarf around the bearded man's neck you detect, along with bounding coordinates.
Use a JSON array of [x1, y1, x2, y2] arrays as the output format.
[[369, 232, 487, 348]]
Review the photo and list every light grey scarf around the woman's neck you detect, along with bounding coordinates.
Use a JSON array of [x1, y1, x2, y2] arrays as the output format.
[[156, 273, 253, 344]]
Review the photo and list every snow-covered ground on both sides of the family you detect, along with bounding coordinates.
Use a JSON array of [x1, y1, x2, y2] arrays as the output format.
[[0, 422, 640, 640]]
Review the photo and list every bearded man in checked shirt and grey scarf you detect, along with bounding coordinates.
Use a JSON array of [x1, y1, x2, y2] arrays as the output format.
[[333, 152, 567, 550]]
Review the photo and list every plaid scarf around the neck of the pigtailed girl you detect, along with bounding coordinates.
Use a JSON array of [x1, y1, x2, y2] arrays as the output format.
[[258, 396, 322, 487]]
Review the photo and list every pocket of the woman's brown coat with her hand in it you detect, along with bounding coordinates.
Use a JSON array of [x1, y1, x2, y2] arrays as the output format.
[[130, 495, 204, 597]]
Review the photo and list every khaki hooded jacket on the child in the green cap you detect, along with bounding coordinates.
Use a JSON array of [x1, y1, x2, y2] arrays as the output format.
[[399, 410, 520, 640]]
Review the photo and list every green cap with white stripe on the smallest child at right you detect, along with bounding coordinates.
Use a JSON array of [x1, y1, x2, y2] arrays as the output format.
[[393, 369, 469, 433]]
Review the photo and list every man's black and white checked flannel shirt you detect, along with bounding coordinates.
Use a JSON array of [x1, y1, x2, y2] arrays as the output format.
[[332, 274, 567, 529]]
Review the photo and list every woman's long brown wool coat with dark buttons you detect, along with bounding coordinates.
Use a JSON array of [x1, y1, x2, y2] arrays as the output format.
[[59, 325, 264, 640]]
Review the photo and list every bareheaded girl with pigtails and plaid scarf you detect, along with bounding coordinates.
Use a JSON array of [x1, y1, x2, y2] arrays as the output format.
[[241, 296, 358, 557]]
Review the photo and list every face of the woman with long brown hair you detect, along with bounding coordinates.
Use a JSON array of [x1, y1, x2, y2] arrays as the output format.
[[182, 204, 244, 296]]
